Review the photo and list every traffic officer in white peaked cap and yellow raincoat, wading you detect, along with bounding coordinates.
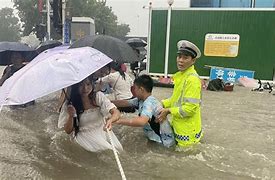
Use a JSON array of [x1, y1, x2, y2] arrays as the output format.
[[158, 40, 202, 147]]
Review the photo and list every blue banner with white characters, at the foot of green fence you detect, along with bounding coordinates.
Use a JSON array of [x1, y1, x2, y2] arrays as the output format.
[[210, 67, 254, 83]]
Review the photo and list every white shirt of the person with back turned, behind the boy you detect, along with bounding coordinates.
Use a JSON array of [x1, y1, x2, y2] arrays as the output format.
[[101, 71, 133, 100]]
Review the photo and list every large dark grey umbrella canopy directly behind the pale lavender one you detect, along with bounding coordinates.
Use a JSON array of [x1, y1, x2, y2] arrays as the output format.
[[70, 35, 138, 63]]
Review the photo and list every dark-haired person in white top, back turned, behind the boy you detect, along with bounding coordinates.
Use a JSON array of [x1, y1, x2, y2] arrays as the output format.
[[99, 61, 135, 112]]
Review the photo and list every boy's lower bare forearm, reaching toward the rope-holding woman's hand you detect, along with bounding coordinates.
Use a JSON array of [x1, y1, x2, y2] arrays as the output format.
[[115, 116, 149, 127]]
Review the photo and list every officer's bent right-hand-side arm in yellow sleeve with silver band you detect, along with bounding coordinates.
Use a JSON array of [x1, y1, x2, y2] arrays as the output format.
[[169, 76, 201, 118]]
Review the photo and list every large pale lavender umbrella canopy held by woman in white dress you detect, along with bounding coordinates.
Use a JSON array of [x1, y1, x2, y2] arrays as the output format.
[[0, 47, 112, 106]]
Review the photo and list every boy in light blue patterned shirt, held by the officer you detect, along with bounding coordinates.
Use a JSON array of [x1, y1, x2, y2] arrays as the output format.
[[112, 75, 175, 147]]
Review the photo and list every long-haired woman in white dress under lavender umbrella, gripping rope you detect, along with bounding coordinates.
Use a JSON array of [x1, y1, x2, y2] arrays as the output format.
[[58, 76, 123, 152]]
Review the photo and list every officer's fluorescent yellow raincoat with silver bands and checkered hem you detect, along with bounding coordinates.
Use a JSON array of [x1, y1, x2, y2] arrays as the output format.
[[162, 66, 202, 147]]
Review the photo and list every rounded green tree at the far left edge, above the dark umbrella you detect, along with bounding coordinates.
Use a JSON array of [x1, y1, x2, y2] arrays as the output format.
[[0, 8, 20, 41]]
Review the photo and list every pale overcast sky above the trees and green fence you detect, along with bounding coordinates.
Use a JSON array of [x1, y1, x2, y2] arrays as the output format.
[[0, 0, 189, 36]]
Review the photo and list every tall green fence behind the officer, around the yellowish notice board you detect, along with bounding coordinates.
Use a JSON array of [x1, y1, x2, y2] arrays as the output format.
[[149, 10, 275, 80]]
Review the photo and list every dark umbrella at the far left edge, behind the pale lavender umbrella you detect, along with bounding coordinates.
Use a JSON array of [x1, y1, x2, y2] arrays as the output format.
[[0, 41, 37, 66]]
